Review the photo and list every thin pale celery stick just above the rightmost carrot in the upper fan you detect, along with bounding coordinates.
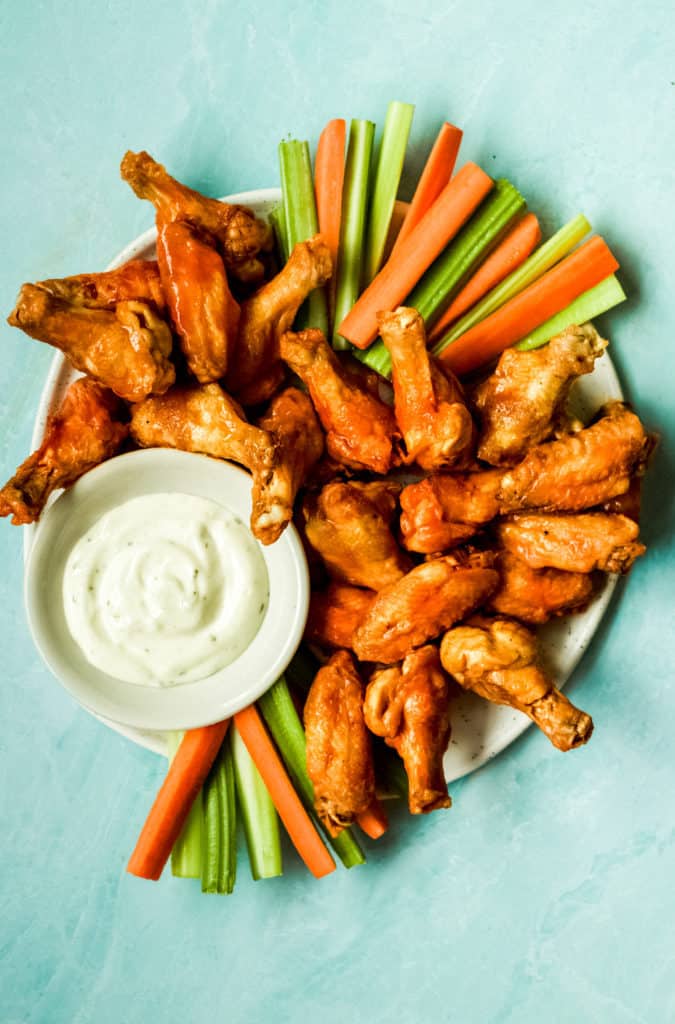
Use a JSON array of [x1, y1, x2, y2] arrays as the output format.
[[433, 213, 591, 355]]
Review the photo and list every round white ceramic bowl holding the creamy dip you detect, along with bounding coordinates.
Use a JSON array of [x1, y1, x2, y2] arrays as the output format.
[[25, 449, 309, 730]]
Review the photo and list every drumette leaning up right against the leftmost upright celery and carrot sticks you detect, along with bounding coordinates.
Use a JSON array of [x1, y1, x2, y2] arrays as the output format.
[[227, 234, 333, 406]]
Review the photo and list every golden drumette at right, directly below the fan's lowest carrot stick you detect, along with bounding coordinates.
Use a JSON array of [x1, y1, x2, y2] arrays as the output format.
[[473, 324, 607, 466]]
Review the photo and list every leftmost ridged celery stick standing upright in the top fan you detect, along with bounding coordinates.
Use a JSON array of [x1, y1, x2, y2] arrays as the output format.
[[279, 139, 328, 334]]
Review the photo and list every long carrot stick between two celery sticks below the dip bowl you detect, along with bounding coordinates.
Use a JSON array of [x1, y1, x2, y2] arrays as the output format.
[[235, 705, 335, 879]]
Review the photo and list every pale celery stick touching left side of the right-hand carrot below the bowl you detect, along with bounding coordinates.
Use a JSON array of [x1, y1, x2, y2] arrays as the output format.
[[230, 726, 283, 881]]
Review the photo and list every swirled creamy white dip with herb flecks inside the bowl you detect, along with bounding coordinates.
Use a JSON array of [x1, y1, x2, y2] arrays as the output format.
[[64, 494, 269, 686]]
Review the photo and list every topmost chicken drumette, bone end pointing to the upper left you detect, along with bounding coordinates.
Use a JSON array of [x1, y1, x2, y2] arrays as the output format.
[[120, 152, 271, 282]]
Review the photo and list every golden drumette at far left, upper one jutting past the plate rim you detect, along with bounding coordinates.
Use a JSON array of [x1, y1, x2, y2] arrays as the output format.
[[8, 285, 175, 401]]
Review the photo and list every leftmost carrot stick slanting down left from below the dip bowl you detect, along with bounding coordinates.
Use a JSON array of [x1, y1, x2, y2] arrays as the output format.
[[127, 719, 229, 882]]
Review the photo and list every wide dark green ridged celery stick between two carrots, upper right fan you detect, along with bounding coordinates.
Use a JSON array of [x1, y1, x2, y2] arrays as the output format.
[[354, 178, 525, 377]]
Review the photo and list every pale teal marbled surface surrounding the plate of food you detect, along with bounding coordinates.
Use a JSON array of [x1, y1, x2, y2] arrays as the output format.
[[0, 0, 675, 1024]]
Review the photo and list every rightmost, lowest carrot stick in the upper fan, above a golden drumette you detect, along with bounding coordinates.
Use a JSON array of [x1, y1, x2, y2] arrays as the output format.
[[434, 234, 619, 374]]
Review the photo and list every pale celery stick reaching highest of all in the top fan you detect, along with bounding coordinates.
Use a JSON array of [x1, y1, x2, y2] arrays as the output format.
[[362, 100, 415, 288]]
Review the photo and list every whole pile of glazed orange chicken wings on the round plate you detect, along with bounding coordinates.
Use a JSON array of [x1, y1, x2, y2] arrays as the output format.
[[0, 153, 653, 835]]
